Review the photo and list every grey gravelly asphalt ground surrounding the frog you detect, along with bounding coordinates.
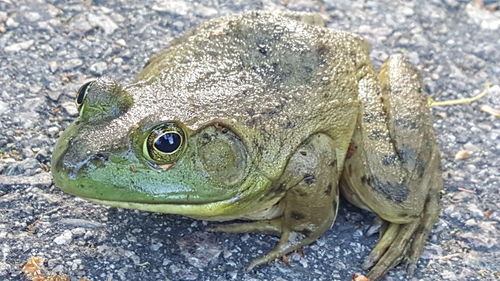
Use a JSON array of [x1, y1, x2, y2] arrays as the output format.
[[0, 0, 500, 280]]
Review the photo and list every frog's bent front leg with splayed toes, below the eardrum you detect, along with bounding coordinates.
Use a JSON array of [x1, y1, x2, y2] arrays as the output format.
[[207, 134, 339, 270]]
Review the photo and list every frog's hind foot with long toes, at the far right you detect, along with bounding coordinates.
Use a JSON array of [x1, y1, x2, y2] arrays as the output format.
[[363, 183, 440, 281]]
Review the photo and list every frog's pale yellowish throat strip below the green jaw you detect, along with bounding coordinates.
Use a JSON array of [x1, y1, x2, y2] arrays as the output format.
[[84, 174, 276, 220]]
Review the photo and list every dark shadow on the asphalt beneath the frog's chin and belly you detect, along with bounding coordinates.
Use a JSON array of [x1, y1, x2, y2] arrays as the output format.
[[99, 198, 377, 275]]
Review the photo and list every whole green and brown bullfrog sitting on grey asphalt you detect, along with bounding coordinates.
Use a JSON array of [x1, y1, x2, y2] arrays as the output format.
[[52, 11, 442, 280]]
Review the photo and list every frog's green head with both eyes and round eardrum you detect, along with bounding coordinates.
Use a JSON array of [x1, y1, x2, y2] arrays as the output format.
[[52, 80, 270, 218]]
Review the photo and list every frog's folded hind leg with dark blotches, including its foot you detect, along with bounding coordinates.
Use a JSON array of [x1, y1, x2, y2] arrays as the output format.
[[341, 55, 443, 280]]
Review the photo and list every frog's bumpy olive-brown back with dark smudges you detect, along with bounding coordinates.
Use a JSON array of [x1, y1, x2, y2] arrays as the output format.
[[132, 12, 368, 178]]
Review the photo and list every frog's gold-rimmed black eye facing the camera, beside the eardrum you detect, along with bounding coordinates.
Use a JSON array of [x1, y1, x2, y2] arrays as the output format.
[[143, 123, 185, 164]]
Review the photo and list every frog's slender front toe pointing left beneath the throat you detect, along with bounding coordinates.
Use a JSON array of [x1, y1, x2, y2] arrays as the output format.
[[206, 218, 282, 236]]
